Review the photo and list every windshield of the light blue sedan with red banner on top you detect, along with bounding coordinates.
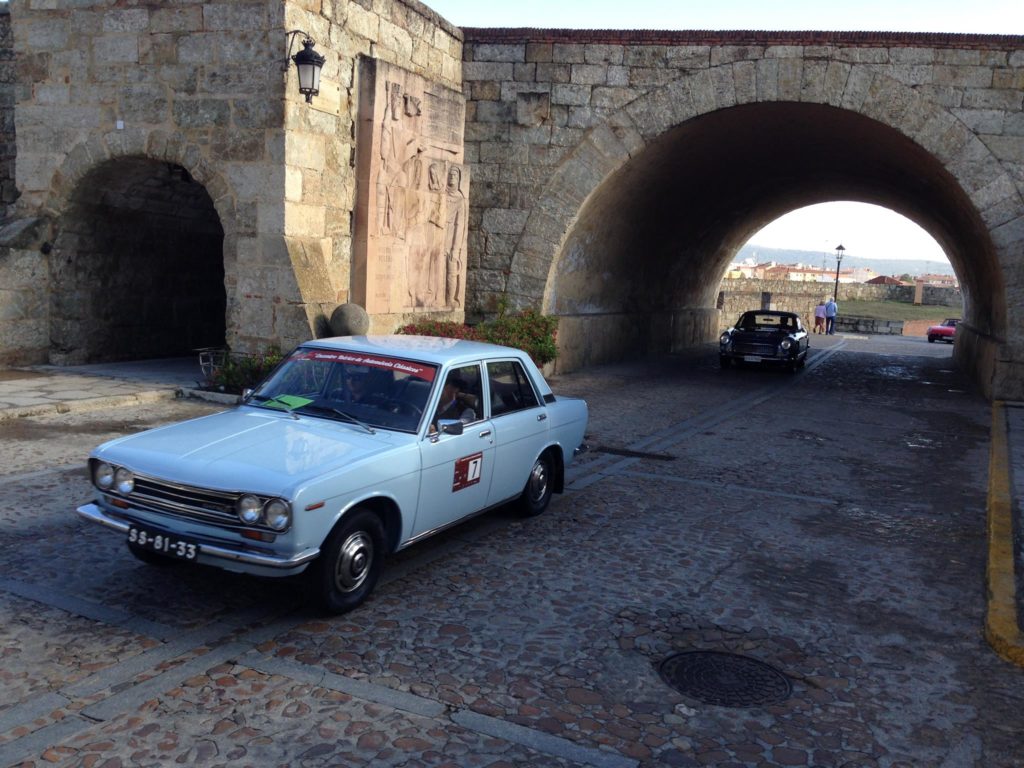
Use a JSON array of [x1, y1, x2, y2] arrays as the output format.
[[246, 347, 437, 432]]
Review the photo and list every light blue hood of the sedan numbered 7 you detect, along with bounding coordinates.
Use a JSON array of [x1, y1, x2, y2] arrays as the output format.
[[92, 407, 416, 495]]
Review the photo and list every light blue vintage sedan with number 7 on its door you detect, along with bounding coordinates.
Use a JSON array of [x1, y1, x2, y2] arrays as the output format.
[[78, 336, 588, 613]]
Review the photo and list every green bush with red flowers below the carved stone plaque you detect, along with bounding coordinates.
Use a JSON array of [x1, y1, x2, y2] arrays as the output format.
[[398, 306, 558, 366]]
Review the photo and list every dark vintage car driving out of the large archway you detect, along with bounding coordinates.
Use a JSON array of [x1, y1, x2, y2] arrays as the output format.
[[719, 309, 809, 371]]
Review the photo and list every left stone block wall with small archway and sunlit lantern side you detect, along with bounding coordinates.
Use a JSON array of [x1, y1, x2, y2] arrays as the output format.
[[0, 0, 462, 361]]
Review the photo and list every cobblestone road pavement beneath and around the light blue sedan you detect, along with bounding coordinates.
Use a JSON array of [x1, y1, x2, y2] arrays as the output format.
[[0, 337, 1024, 768]]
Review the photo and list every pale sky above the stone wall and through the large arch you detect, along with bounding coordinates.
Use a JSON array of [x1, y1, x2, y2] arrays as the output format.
[[425, 0, 1024, 262]]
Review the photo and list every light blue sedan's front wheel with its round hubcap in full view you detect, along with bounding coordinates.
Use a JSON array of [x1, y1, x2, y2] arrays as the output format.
[[307, 509, 384, 613]]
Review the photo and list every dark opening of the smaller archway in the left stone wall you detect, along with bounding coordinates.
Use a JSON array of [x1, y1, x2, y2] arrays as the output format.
[[49, 156, 226, 365]]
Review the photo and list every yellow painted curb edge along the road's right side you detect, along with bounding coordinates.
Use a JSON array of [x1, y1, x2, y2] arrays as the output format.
[[985, 400, 1024, 667]]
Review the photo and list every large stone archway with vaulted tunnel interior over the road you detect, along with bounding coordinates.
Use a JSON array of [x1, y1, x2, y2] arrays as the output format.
[[491, 58, 1024, 393]]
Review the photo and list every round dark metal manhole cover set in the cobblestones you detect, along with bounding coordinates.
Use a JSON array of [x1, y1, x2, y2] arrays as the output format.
[[658, 651, 793, 707]]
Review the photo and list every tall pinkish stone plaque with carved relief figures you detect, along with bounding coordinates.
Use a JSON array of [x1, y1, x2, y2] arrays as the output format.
[[352, 58, 469, 314]]
